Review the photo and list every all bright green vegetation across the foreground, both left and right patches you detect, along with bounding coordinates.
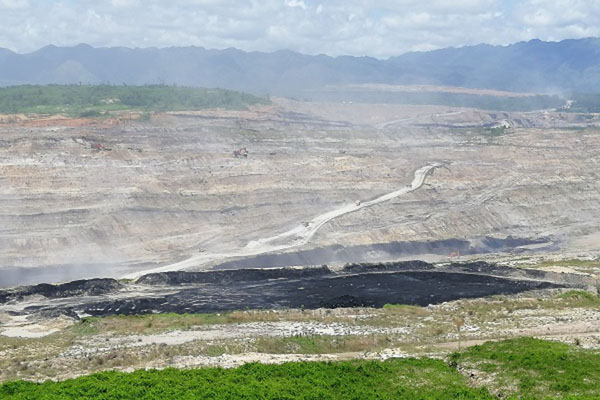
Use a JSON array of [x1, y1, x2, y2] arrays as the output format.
[[0, 338, 600, 400]]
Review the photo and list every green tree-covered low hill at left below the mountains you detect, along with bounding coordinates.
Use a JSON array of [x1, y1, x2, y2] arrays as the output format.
[[0, 85, 268, 118]]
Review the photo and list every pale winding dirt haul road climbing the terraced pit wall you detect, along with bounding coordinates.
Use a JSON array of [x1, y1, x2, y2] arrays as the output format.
[[123, 163, 441, 279]]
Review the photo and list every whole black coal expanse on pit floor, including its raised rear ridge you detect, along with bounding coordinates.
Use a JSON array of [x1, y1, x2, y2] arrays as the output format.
[[4, 261, 580, 316]]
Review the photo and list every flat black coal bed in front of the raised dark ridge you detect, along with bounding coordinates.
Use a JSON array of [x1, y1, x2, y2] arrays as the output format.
[[24, 270, 564, 316]]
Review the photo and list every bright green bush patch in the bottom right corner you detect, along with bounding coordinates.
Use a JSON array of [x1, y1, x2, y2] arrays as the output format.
[[450, 338, 600, 399]]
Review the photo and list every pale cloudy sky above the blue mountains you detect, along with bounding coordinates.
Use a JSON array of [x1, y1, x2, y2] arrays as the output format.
[[0, 0, 600, 58]]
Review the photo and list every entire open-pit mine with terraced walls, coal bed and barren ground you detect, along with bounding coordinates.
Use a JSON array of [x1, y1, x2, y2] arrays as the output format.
[[0, 92, 600, 381]]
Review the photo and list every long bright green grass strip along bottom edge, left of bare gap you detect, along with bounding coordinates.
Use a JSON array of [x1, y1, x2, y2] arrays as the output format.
[[0, 359, 492, 400]]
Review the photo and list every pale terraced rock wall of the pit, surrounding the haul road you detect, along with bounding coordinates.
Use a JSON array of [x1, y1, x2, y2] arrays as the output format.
[[0, 101, 600, 286]]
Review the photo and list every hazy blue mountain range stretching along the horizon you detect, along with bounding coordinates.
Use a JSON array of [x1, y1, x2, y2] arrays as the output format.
[[0, 38, 600, 94]]
